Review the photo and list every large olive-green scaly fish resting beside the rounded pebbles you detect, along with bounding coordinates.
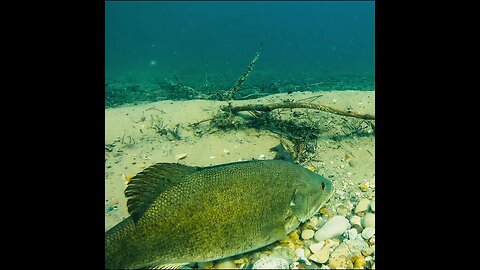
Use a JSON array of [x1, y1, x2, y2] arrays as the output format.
[[105, 159, 334, 269]]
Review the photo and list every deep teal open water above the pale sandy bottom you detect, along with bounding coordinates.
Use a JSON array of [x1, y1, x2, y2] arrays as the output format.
[[105, 1, 375, 107]]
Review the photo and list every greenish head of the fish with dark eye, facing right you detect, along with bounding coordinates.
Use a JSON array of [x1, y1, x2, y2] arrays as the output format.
[[290, 169, 334, 222]]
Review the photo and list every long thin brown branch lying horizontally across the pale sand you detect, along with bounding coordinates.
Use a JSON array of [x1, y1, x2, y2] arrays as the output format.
[[221, 102, 375, 120]]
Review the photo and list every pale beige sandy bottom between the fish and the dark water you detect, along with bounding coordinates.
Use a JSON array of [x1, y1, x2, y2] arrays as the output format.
[[105, 91, 375, 231]]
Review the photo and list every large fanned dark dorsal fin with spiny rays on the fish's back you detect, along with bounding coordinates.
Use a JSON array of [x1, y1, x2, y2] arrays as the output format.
[[125, 163, 200, 222]]
